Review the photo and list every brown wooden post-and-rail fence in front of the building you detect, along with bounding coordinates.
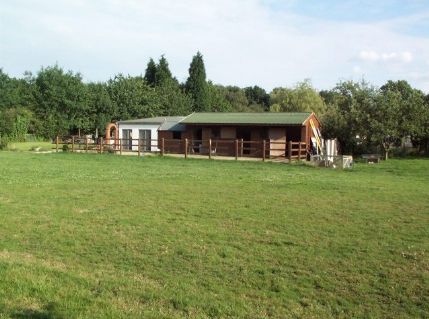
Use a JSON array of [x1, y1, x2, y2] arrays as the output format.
[[53, 136, 308, 161]]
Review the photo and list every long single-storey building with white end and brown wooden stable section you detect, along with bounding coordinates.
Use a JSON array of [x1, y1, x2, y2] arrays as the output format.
[[106, 112, 320, 157]]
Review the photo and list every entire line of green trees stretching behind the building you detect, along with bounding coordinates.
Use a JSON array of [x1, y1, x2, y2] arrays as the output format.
[[0, 52, 429, 157]]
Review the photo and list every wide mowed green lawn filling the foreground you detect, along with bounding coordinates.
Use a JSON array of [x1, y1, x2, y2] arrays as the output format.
[[0, 152, 429, 318]]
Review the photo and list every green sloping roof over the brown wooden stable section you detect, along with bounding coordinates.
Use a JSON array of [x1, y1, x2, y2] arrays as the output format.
[[180, 112, 311, 125]]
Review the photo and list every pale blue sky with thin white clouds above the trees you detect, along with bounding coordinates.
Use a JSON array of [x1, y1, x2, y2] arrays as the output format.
[[0, 0, 429, 93]]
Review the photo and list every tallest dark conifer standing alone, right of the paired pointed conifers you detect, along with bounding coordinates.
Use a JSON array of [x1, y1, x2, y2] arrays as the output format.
[[185, 52, 210, 112]]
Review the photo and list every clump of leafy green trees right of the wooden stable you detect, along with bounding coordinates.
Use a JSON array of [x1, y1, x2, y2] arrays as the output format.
[[321, 81, 429, 158]]
